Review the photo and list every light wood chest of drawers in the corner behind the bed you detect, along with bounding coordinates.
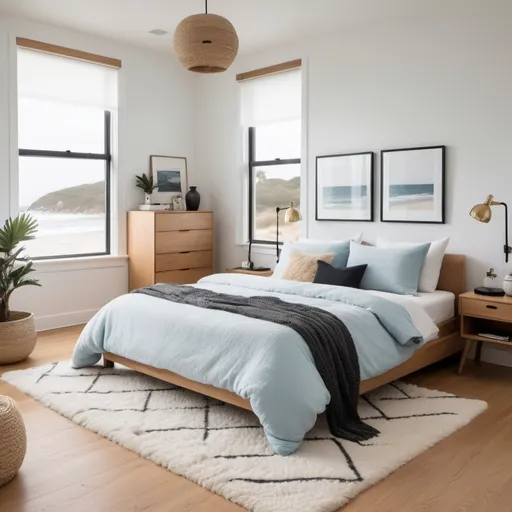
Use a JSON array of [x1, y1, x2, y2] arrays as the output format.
[[128, 211, 213, 290]]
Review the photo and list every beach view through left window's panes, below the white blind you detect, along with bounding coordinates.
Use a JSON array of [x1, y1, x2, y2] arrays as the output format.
[[18, 99, 107, 258]]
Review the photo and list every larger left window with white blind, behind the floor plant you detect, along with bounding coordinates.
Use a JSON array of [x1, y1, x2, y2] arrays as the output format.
[[18, 47, 117, 259]]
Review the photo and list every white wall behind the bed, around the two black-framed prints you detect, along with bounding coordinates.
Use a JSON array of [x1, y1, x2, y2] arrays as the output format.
[[196, 4, 512, 362]]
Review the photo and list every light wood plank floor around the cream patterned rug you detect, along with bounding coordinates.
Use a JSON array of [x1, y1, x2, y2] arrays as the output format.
[[0, 327, 512, 512]]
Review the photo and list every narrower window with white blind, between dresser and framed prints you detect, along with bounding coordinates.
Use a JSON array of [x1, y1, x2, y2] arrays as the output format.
[[241, 65, 302, 243]]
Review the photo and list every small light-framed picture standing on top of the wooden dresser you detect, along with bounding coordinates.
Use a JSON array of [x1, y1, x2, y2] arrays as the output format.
[[150, 155, 187, 204]]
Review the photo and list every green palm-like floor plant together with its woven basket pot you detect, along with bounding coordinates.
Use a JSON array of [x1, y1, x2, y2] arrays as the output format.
[[0, 214, 40, 364]]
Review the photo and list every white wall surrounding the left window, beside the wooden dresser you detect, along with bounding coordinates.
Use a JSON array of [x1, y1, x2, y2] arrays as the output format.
[[0, 19, 196, 329]]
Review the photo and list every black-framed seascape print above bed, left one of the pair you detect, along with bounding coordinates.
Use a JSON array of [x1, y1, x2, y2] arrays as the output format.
[[315, 152, 374, 221]]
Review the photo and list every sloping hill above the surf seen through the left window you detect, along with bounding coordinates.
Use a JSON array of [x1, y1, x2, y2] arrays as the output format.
[[28, 181, 105, 214]]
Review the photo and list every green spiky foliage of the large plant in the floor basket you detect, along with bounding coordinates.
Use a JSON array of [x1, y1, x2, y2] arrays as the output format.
[[0, 213, 41, 322]]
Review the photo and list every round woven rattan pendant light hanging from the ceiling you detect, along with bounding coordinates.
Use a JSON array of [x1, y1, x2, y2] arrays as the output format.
[[174, 0, 238, 73]]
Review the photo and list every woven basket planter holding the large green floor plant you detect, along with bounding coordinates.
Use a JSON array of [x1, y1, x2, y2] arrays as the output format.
[[0, 311, 37, 364]]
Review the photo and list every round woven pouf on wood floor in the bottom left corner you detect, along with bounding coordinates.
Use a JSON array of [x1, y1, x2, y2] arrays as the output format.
[[0, 396, 27, 487]]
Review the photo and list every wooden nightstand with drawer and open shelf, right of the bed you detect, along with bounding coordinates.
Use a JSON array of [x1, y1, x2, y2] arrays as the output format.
[[459, 292, 512, 373]]
